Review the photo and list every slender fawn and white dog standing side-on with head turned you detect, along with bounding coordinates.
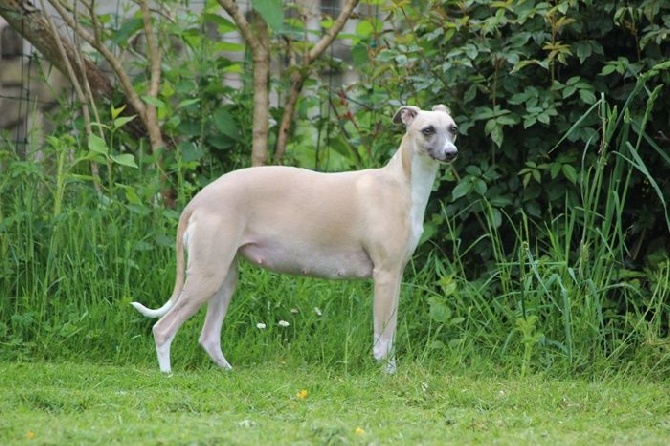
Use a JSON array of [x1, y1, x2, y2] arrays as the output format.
[[132, 105, 458, 373]]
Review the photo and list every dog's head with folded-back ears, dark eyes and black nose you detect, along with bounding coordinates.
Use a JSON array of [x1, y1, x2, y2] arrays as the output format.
[[393, 105, 458, 163]]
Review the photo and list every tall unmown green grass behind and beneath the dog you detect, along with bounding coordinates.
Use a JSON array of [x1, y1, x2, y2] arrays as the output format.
[[0, 68, 670, 377]]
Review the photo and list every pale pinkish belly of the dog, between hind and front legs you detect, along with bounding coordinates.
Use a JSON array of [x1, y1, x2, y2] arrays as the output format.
[[239, 242, 373, 279]]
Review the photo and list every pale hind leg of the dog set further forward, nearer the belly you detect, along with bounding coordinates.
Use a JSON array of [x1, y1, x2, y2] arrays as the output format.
[[200, 260, 237, 369]]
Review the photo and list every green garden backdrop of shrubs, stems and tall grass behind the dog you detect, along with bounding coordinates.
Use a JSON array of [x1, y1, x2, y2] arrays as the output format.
[[0, 0, 670, 436]]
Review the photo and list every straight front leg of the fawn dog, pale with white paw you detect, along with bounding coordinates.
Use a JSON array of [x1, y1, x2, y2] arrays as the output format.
[[373, 270, 402, 374]]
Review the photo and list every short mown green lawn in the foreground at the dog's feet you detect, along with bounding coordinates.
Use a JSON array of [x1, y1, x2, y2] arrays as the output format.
[[0, 361, 670, 445]]
